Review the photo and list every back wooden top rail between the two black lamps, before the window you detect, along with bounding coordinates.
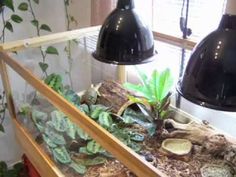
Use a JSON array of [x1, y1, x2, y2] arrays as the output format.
[[153, 31, 196, 50]]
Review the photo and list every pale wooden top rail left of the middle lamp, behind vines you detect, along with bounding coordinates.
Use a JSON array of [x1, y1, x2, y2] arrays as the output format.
[[0, 26, 100, 52]]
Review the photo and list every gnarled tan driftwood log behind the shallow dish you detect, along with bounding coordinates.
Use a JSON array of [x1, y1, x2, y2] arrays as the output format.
[[162, 119, 236, 158]]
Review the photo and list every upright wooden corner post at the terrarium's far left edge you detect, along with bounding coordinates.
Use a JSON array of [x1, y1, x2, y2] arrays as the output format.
[[0, 59, 16, 118]]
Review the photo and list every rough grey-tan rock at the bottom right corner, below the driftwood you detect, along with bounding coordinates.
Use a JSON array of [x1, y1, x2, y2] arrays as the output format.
[[201, 164, 234, 177]]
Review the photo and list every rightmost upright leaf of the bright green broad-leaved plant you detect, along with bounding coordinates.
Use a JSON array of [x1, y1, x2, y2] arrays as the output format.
[[156, 69, 174, 101]]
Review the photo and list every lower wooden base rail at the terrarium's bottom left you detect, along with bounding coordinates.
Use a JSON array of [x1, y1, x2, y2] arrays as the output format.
[[13, 118, 64, 177]]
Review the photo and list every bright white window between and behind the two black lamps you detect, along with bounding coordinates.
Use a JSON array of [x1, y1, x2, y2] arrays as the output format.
[[135, 0, 226, 41]]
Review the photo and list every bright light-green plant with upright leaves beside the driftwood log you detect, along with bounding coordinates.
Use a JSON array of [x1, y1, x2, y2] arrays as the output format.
[[124, 68, 174, 134]]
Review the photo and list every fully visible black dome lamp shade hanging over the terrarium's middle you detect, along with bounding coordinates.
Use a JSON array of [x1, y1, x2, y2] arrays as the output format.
[[93, 0, 155, 65]]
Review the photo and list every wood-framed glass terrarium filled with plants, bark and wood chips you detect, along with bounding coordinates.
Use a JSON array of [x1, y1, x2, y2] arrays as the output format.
[[0, 27, 236, 177]]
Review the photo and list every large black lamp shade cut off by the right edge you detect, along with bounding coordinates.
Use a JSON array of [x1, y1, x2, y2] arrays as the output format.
[[177, 15, 236, 111]]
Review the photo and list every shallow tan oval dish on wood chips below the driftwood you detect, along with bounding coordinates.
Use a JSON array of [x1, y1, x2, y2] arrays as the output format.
[[161, 138, 192, 156]]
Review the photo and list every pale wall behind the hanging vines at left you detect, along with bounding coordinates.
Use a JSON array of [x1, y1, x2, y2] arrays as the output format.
[[0, 0, 91, 164]]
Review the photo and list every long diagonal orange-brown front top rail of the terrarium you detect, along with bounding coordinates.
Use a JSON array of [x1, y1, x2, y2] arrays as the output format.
[[0, 52, 166, 177]]
